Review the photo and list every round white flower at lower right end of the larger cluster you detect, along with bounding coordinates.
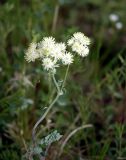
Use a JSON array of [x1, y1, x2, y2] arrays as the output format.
[[62, 52, 73, 65]]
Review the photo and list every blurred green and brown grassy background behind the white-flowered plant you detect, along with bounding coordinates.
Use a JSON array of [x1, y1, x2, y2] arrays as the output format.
[[0, 0, 126, 160]]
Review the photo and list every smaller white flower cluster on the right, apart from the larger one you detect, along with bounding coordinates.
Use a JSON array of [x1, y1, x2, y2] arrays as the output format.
[[68, 32, 90, 57]]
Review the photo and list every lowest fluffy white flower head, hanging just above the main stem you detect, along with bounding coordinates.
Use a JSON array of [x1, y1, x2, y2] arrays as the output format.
[[42, 58, 55, 71]]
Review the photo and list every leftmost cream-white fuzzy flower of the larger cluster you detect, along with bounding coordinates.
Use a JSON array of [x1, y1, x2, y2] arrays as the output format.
[[25, 43, 39, 62]]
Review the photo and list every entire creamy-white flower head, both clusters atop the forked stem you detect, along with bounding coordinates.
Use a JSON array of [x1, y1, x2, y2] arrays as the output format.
[[25, 32, 90, 71]]
